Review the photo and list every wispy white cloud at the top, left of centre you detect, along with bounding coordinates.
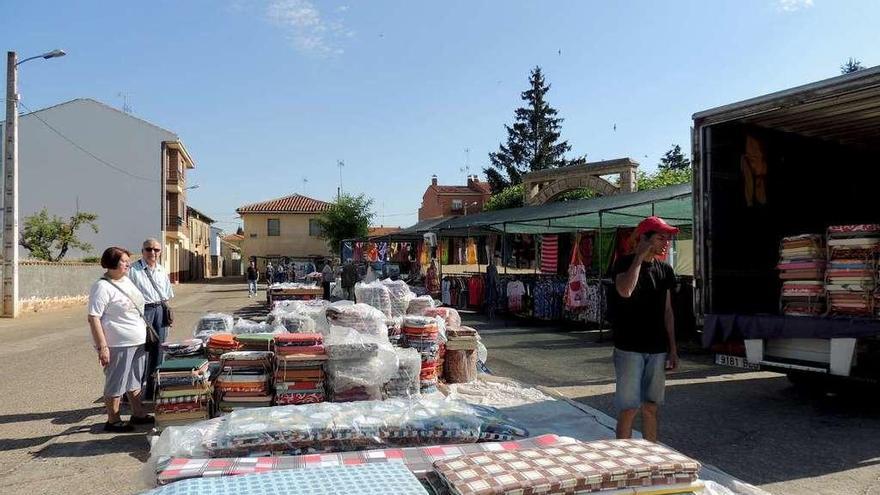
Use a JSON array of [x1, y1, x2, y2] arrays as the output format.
[[265, 0, 354, 57]]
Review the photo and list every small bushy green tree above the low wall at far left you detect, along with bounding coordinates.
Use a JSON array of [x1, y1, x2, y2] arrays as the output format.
[[18, 208, 98, 261]]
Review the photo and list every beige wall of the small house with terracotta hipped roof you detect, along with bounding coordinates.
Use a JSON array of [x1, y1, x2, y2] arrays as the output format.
[[242, 213, 330, 269]]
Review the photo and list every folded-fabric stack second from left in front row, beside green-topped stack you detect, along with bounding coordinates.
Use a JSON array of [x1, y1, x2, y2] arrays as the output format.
[[215, 351, 273, 413]]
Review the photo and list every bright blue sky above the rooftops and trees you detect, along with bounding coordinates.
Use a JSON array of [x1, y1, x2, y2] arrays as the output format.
[[0, 0, 880, 230]]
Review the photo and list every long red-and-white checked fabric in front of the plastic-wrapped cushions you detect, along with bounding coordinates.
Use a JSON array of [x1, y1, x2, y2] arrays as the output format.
[[156, 435, 577, 485]]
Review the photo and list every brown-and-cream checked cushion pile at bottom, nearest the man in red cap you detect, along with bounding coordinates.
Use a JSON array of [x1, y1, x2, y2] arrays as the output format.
[[434, 440, 701, 495]]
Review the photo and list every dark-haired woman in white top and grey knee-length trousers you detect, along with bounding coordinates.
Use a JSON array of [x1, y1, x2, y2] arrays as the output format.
[[89, 247, 155, 433]]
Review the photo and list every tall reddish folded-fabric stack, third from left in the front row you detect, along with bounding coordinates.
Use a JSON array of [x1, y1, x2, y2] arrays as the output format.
[[275, 333, 327, 406]]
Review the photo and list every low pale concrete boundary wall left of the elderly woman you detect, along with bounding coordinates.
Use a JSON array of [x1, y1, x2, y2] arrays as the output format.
[[18, 261, 105, 311]]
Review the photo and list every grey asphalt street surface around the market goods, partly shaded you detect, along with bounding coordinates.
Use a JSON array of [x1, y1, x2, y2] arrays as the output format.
[[0, 281, 880, 495]]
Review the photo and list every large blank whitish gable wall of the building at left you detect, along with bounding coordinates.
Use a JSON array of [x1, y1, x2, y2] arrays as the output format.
[[8, 99, 177, 259]]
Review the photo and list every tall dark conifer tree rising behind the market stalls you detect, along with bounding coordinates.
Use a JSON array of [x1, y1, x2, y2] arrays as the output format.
[[483, 67, 586, 191]]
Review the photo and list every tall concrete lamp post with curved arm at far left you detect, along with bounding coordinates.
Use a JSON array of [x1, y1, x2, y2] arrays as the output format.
[[3, 50, 66, 318]]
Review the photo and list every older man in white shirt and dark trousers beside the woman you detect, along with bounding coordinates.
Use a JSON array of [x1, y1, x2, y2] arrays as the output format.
[[128, 238, 174, 400]]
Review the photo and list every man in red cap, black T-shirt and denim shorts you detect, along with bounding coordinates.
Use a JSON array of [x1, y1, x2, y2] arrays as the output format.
[[609, 217, 678, 442]]
